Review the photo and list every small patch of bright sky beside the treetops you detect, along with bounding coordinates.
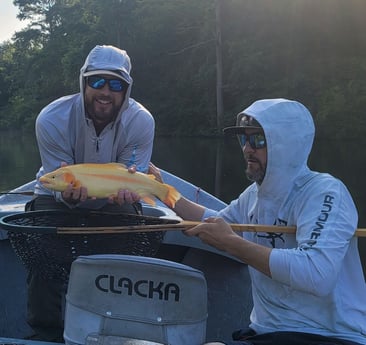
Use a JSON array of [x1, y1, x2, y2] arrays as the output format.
[[0, 0, 26, 43]]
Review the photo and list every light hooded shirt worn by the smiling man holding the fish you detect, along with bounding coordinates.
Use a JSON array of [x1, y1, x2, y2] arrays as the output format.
[[35, 46, 155, 199]]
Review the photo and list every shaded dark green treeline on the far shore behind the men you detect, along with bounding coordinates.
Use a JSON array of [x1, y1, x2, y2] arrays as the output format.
[[0, 0, 366, 137]]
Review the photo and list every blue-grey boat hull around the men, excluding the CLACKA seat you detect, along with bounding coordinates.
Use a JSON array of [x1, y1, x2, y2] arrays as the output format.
[[0, 171, 252, 344]]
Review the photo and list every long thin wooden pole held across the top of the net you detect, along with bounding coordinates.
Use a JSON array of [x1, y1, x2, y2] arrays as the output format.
[[56, 221, 366, 237]]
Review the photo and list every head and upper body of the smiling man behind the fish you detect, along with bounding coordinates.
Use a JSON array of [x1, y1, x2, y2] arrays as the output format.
[[35, 46, 155, 207]]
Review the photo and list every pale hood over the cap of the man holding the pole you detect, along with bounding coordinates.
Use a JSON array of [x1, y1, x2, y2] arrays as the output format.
[[232, 99, 315, 199]]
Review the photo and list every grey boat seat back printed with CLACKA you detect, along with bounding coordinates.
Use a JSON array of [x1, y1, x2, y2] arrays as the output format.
[[64, 254, 207, 345]]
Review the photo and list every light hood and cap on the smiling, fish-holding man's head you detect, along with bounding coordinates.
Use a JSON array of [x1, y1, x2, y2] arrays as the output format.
[[80, 45, 133, 118]]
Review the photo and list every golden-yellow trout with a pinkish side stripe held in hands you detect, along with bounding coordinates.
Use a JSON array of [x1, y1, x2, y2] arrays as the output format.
[[39, 163, 181, 208]]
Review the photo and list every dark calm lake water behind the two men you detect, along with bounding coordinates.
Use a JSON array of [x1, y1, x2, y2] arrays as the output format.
[[0, 132, 366, 274]]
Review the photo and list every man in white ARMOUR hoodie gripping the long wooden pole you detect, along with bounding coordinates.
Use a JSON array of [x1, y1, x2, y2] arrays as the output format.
[[150, 99, 366, 345]]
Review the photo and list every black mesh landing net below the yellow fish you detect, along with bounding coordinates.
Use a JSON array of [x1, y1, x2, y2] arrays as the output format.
[[2, 211, 176, 281]]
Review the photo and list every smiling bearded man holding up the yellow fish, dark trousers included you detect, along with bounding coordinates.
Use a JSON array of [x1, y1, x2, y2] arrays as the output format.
[[27, 45, 155, 342]]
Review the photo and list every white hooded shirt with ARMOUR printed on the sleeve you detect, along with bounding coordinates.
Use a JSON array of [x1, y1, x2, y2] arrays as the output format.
[[204, 99, 366, 344]]
